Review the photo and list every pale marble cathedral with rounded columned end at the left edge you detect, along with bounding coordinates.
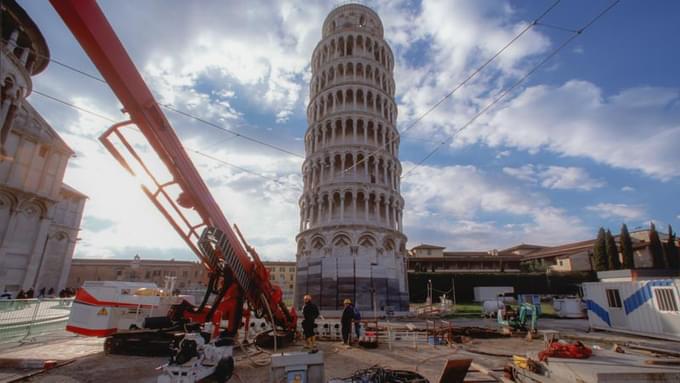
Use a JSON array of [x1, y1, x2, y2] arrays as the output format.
[[0, 0, 86, 292]]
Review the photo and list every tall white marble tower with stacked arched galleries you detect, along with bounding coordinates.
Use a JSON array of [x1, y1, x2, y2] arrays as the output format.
[[295, 4, 408, 315]]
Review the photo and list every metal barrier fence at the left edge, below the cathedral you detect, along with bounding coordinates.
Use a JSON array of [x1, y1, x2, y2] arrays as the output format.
[[0, 298, 73, 343]]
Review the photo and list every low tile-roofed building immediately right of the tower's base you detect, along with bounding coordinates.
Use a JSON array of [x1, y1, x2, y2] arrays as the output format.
[[407, 244, 528, 273]]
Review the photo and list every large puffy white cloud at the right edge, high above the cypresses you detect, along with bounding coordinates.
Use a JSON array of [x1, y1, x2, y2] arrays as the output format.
[[464, 80, 680, 180]]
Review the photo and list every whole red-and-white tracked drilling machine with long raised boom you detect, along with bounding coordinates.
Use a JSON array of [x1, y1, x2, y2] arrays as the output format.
[[50, 0, 297, 380]]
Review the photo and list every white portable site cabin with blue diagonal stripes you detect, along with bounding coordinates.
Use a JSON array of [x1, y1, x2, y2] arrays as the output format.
[[582, 270, 680, 341]]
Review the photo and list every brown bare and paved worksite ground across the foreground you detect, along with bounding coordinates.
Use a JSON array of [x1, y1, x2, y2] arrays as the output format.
[[0, 318, 680, 383]]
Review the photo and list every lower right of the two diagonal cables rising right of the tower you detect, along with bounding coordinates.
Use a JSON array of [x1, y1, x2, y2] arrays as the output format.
[[401, 0, 621, 179]]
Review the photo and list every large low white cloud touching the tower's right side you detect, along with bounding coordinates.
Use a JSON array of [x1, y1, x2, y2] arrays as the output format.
[[402, 163, 589, 249]]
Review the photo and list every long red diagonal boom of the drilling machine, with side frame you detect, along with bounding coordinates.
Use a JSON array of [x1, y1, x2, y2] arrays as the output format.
[[50, 0, 291, 327]]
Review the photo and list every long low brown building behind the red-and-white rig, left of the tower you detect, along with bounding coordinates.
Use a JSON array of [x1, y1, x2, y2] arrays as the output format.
[[67, 256, 208, 290]]
